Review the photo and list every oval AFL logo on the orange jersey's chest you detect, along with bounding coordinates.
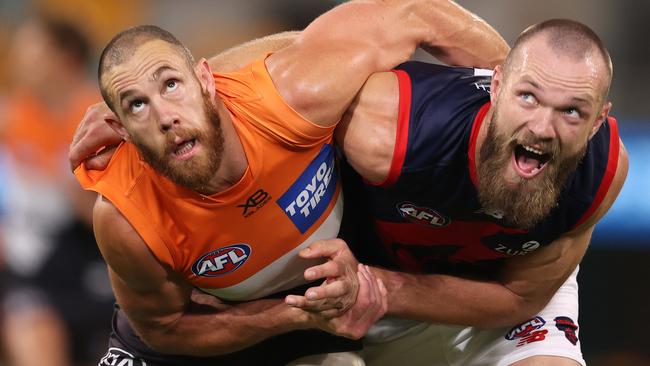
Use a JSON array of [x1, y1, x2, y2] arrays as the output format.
[[192, 244, 251, 277]]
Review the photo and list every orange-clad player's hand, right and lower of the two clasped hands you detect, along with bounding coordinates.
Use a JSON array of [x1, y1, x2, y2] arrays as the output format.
[[311, 264, 388, 339]]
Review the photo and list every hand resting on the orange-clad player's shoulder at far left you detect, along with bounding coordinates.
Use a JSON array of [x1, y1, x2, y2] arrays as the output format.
[[68, 102, 122, 171]]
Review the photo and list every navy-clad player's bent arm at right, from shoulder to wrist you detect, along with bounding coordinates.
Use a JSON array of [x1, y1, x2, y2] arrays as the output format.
[[373, 144, 628, 327]]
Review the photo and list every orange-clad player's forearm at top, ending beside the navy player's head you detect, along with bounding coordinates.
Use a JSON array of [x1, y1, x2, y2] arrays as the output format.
[[418, 0, 510, 69]]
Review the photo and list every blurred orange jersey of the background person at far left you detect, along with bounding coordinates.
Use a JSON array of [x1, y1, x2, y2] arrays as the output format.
[[2, 88, 100, 176]]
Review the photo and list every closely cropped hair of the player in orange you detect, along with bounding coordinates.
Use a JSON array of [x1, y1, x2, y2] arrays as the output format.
[[97, 25, 194, 112]]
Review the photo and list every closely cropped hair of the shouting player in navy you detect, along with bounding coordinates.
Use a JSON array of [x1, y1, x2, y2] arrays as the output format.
[[504, 19, 613, 100]]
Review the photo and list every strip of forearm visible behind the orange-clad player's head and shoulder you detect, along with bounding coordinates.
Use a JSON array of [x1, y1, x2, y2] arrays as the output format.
[[208, 31, 300, 72]]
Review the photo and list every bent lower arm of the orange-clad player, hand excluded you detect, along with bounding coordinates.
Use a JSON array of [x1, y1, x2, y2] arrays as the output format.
[[94, 198, 308, 356]]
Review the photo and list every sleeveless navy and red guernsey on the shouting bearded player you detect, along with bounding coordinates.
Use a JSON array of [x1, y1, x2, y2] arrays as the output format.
[[344, 62, 619, 272]]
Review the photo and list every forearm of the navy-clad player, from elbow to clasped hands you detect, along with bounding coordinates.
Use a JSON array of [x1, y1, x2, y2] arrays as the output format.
[[373, 268, 544, 327]]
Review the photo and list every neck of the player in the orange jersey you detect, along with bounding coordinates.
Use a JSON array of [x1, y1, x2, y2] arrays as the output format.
[[199, 98, 248, 195]]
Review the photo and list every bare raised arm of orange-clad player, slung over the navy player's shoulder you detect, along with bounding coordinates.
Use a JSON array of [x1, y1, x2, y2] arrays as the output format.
[[266, 0, 507, 126]]
